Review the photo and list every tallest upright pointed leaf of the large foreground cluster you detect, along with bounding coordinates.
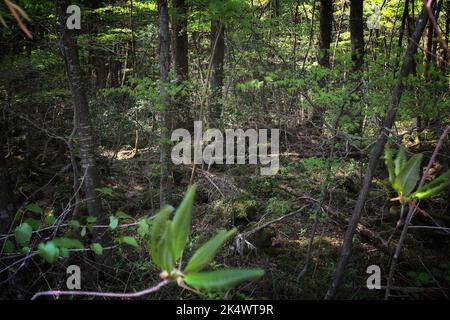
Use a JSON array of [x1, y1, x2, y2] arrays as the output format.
[[172, 185, 197, 260]]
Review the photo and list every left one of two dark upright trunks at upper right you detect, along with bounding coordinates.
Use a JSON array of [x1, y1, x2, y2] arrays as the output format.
[[319, 0, 333, 68]]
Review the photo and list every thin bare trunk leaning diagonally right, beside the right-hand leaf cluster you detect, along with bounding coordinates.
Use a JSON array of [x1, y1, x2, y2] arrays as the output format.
[[325, 5, 428, 299]]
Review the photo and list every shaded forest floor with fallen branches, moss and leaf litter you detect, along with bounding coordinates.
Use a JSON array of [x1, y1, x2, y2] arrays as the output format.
[[3, 129, 450, 299]]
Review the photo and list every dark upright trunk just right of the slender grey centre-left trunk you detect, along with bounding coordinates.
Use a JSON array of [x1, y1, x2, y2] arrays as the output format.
[[172, 0, 193, 130]]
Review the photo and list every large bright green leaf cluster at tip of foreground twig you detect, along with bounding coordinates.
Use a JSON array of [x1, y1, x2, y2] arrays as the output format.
[[144, 186, 263, 290]]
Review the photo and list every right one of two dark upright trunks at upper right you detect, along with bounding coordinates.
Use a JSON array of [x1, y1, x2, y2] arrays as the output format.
[[350, 0, 364, 71]]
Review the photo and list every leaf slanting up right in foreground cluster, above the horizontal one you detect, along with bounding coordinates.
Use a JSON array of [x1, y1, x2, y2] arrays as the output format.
[[183, 229, 237, 274]]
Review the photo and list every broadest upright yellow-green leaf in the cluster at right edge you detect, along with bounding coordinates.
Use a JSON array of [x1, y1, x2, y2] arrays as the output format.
[[394, 154, 423, 197]]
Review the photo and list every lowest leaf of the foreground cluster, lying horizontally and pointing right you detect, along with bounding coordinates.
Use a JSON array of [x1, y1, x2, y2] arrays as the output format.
[[183, 269, 264, 290]]
